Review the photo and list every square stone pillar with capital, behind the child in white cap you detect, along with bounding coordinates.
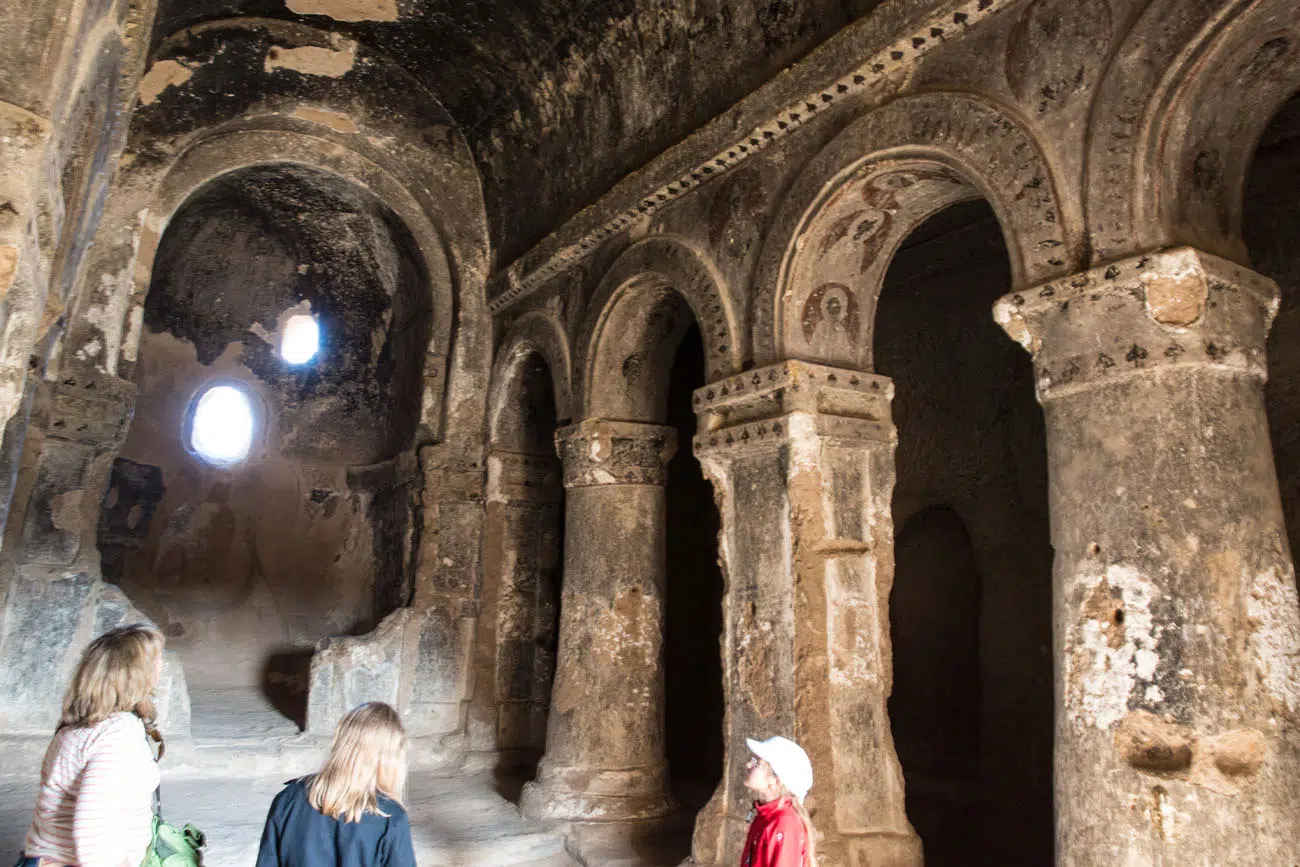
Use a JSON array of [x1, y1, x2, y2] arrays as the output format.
[[694, 361, 922, 867]]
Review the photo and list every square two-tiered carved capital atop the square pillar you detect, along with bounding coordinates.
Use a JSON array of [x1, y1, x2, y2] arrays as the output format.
[[694, 359, 897, 455]]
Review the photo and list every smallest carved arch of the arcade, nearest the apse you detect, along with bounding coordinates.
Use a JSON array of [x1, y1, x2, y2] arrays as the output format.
[[488, 311, 573, 447]]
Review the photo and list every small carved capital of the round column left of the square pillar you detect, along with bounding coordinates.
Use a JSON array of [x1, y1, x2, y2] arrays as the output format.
[[555, 419, 677, 487]]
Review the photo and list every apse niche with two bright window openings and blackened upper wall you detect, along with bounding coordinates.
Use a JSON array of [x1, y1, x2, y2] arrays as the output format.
[[99, 165, 430, 740]]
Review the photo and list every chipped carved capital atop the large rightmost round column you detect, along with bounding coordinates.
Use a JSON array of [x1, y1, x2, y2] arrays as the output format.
[[993, 247, 1278, 400]]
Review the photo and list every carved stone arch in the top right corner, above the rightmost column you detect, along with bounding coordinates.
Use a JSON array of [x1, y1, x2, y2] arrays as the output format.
[[1086, 0, 1300, 264]]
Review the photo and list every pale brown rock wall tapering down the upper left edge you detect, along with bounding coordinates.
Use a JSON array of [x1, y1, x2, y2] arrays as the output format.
[[0, 0, 155, 535]]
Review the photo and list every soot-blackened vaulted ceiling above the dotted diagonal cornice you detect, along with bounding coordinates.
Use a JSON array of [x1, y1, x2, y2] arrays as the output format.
[[153, 0, 881, 265]]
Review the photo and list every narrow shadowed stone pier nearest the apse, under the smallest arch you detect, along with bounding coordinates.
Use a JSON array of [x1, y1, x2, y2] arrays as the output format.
[[469, 448, 564, 758]]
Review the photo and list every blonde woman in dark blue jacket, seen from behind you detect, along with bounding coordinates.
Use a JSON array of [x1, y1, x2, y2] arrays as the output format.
[[257, 702, 415, 867]]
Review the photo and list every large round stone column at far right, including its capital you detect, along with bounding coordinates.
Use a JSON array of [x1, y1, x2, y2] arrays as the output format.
[[996, 248, 1300, 867]]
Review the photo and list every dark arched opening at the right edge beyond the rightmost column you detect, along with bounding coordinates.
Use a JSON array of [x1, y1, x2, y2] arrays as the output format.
[[1243, 95, 1300, 569]]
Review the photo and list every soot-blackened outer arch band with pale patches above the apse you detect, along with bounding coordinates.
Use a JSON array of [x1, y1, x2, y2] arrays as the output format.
[[135, 18, 488, 266]]
